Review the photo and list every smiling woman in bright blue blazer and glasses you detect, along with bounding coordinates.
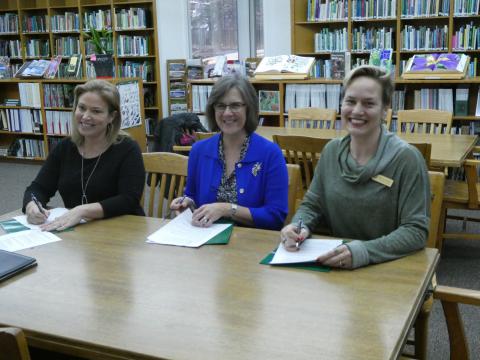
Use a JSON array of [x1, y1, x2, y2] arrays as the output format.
[[170, 75, 288, 230]]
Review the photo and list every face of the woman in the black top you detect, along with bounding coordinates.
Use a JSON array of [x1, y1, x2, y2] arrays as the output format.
[[75, 92, 114, 139]]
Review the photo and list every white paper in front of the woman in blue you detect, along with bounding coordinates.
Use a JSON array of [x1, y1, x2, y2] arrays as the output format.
[[147, 209, 232, 247]]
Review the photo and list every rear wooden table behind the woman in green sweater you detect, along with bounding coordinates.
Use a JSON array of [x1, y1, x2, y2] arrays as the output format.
[[256, 126, 477, 167]]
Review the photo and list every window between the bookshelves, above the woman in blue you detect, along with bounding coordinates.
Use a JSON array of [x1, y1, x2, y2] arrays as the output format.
[[188, 0, 263, 60]]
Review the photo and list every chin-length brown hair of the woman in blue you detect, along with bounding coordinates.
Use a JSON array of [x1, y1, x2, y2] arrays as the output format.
[[205, 74, 258, 134]]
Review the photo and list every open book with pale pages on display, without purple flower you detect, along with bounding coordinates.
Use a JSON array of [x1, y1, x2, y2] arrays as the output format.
[[255, 55, 315, 80]]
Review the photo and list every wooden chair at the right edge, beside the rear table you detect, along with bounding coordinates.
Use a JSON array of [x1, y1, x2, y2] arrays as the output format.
[[438, 146, 480, 249]]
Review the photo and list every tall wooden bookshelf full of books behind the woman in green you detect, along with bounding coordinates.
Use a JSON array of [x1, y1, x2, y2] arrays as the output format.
[[290, 0, 480, 134]]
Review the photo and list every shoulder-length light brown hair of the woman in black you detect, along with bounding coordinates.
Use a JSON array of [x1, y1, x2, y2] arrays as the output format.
[[71, 80, 128, 146]]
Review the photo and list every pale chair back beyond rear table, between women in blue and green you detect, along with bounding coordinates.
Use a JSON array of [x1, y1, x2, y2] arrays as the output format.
[[288, 108, 337, 129]]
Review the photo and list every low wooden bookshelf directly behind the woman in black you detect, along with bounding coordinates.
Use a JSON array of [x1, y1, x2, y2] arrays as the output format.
[[0, 78, 147, 161]]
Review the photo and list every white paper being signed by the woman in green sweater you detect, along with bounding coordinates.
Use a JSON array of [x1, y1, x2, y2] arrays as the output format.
[[270, 239, 343, 265]]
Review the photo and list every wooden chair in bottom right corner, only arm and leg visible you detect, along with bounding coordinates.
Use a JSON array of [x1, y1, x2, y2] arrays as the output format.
[[433, 285, 480, 360]]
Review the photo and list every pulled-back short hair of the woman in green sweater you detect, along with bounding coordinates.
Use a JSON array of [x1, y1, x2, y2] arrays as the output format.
[[342, 65, 394, 107]]
